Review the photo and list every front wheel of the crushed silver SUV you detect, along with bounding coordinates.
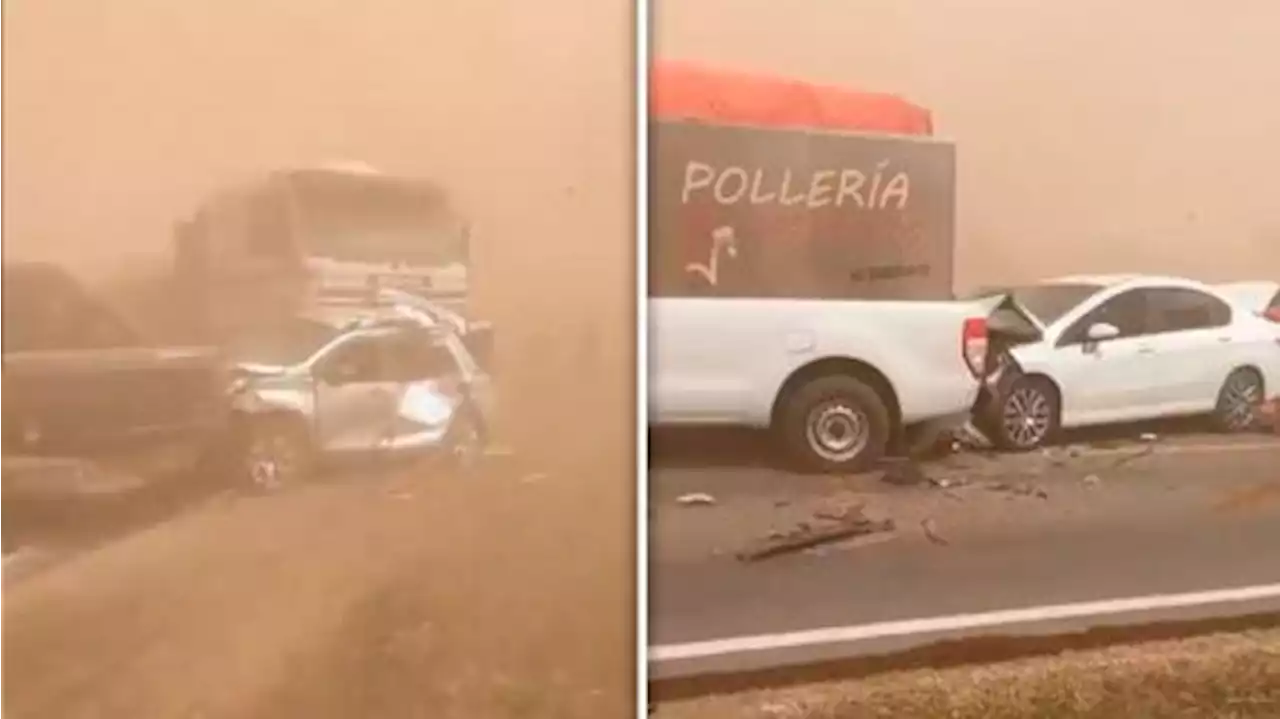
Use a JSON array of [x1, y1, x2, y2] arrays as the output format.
[[232, 415, 315, 491]]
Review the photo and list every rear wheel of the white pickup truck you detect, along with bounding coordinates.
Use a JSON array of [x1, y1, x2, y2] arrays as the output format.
[[776, 375, 891, 472]]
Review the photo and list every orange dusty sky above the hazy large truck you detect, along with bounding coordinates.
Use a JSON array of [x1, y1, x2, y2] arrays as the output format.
[[4, 0, 634, 318]]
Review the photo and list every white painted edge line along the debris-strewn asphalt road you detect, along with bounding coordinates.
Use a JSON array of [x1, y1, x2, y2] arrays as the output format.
[[649, 585, 1280, 663]]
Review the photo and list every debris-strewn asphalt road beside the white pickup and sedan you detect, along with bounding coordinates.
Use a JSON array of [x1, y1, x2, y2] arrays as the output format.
[[649, 424, 1280, 678]]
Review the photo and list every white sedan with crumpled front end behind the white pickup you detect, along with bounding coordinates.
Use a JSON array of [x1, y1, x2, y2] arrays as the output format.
[[975, 275, 1280, 449]]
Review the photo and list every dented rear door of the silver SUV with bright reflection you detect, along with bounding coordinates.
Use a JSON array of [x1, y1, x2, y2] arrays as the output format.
[[378, 330, 466, 449]]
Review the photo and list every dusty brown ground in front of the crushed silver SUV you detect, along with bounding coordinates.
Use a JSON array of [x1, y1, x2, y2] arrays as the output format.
[[0, 427, 635, 719]]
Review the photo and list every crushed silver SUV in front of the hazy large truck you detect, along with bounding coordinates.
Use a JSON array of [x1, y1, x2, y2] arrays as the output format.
[[220, 307, 493, 489]]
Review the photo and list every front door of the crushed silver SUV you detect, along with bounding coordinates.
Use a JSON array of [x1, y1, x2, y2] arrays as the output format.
[[314, 330, 401, 452]]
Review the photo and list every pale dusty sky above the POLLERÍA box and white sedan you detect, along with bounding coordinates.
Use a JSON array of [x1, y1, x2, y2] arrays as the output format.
[[654, 0, 1280, 285]]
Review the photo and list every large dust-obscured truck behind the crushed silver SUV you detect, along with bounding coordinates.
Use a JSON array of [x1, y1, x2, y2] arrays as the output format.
[[175, 162, 471, 340]]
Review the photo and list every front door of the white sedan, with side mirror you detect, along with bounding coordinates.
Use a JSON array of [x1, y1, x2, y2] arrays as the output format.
[[1052, 289, 1157, 426]]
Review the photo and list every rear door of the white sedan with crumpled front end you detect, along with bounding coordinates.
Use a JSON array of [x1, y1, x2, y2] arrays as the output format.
[[1148, 287, 1248, 415]]
